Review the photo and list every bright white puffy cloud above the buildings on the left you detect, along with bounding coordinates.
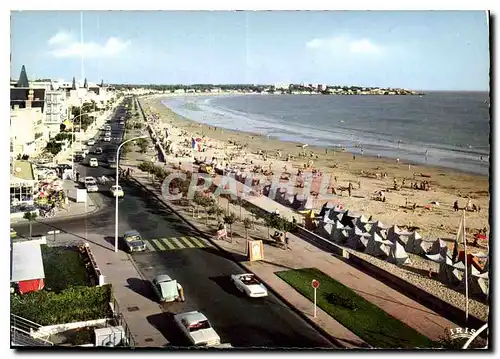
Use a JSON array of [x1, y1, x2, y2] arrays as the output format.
[[49, 31, 131, 58]]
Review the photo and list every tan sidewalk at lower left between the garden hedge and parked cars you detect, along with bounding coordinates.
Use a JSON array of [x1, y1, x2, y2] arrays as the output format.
[[88, 237, 168, 347]]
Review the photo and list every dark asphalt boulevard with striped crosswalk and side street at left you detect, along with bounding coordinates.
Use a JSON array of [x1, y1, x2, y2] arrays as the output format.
[[14, 103, 334, 348]]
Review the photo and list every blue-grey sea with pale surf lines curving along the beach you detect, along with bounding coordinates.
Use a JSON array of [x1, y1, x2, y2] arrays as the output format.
[[162, 91, 490, 176]]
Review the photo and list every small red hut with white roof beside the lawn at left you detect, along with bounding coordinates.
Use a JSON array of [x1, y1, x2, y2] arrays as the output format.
[[10, 240, 45, 294]]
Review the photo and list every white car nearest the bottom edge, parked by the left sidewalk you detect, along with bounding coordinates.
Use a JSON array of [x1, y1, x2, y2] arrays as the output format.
[[174, 311, 220, 347]]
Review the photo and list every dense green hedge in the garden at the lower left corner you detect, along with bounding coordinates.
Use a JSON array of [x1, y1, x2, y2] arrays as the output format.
[[10, 285, 112, 326]]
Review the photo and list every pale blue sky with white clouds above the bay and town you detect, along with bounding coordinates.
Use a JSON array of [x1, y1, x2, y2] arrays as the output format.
[[11, 11, 490, 91]]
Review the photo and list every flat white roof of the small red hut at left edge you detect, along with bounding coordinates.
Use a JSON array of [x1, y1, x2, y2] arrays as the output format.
[[10, 241, 45, 282]]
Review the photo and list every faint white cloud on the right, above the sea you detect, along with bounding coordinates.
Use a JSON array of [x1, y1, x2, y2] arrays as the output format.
[[306, 35, 384, 55]]
